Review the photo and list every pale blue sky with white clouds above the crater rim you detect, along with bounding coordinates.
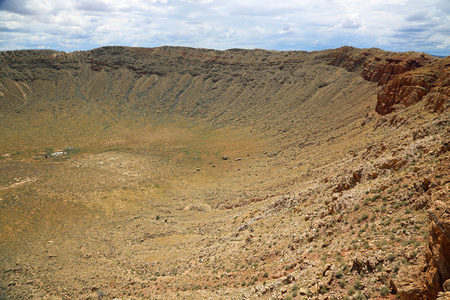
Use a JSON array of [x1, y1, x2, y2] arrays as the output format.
[[0, 0, 450, 56]]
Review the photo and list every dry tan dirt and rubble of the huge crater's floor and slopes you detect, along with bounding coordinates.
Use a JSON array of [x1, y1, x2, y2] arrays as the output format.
[[0, 47, 450, 299]]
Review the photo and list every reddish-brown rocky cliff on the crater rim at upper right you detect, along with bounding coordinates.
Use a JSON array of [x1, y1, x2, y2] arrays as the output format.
[[328, 47, 450, 115]]
